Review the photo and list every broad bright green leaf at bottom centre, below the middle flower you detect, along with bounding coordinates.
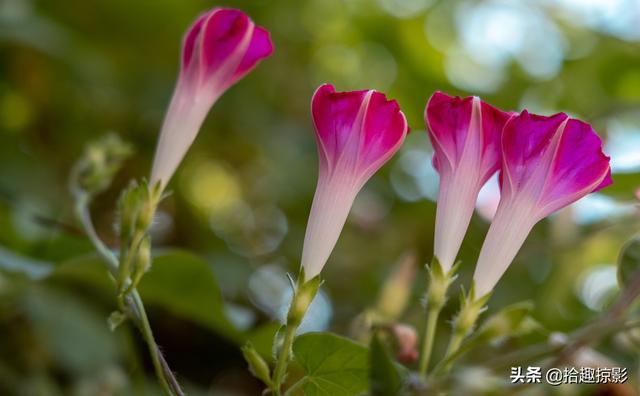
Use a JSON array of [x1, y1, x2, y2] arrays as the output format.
[[293, 333, 369, 396]]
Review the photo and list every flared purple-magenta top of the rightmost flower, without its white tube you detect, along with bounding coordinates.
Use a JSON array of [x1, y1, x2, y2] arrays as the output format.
[[501, 111, 611, 220]]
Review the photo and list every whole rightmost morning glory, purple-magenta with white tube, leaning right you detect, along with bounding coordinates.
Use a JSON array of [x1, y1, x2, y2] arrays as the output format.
[[473, 110, 612, 297]]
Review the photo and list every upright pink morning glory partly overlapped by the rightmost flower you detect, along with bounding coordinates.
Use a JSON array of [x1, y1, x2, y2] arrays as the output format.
[[424, 92, 512, 272]]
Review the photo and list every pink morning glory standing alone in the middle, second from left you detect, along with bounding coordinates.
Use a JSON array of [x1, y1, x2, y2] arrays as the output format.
[[302, 85, 408, 280]]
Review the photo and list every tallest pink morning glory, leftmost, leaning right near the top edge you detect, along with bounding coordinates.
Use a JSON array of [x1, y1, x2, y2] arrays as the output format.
[[151, 8, 273, 187]]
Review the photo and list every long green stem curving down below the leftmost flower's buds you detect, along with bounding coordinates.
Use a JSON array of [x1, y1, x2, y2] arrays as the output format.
[[75, 194, 184, 396]]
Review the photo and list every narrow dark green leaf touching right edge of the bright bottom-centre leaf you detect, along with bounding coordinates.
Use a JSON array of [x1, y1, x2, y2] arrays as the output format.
[[370, 333, 407, 396]]
